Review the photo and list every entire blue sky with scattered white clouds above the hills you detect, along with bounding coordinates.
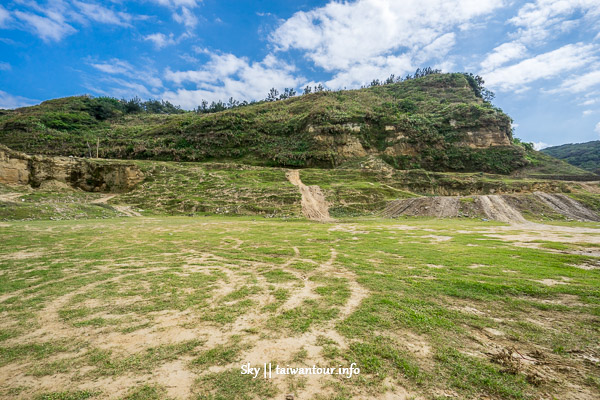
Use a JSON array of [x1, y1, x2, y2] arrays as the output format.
[[0, 0, 600, 145]]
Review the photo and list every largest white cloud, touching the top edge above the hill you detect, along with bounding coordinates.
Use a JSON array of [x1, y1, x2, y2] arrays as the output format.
[[269, 0, 503, 87]]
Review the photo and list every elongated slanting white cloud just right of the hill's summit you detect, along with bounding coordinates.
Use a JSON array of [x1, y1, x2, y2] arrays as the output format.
[[484, 43, 597, 91]]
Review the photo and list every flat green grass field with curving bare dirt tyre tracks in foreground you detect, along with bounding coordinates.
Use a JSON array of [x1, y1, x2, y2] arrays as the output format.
[[0, 217, 600, 399]]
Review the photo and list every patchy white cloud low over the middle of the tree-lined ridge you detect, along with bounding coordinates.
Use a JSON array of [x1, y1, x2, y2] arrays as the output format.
[[162, 53, 305, 109]]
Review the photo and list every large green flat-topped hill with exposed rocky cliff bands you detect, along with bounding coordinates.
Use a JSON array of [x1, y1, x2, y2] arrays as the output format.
[[0, 73, 585, 175]]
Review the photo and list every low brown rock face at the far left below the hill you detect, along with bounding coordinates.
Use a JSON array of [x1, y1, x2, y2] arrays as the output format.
[[0, 145, 144, 192]]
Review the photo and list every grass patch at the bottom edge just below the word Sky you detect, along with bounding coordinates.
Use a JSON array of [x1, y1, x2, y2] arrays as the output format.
[[196, 368, 277, 400]]
